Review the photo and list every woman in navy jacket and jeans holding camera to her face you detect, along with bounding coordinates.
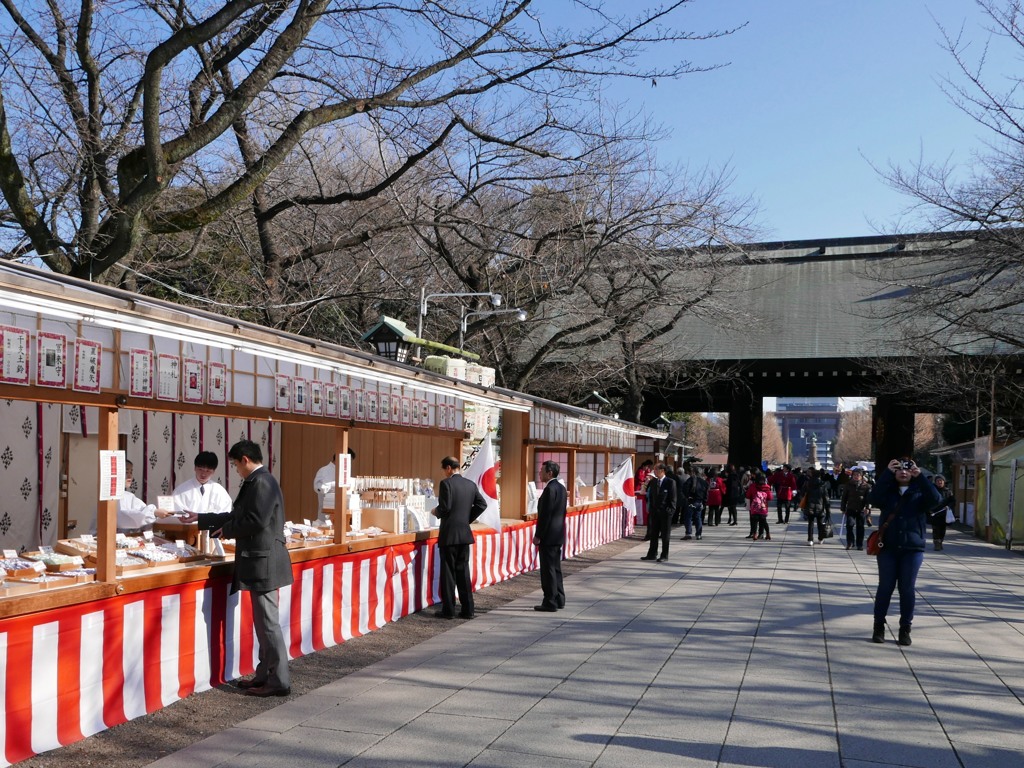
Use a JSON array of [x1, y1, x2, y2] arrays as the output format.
[[868, 459, 941, 645]]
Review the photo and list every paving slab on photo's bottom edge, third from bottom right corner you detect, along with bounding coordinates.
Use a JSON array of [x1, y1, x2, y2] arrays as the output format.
[[719, 713, 841, 768]]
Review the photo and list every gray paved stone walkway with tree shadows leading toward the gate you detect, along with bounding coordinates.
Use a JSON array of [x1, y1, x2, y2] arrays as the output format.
[[154, 515, 1024, 768]]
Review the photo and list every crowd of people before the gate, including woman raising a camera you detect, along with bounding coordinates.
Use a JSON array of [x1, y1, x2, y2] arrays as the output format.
[[634, 458, 954, 645]]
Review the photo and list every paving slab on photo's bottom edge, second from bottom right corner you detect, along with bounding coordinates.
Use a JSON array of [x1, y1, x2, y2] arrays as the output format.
[[839, 729, 961, 768]]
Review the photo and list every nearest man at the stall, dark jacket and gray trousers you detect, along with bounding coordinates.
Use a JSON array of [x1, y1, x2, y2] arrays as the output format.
[[193, 440, 292, 696]]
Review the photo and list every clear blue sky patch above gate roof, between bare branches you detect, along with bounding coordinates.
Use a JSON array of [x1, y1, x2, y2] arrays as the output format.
[[593, 0, 1013, 241]]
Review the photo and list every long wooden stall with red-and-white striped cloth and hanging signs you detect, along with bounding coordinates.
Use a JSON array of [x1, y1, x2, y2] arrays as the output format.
[[0, 264, 647, 763]]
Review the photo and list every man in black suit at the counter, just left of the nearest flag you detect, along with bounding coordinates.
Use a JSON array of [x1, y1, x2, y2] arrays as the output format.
[[433, 456, 487, 618]]
